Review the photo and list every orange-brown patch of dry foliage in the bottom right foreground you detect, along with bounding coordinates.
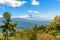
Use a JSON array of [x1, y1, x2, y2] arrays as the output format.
[[37, 33, 54, 40]]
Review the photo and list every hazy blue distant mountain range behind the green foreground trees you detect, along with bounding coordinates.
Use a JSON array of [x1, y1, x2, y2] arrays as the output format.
[[0, 18, 51, 29]]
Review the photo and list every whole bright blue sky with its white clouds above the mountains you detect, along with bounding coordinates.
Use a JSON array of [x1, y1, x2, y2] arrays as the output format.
[[0, 0, 60, 20]]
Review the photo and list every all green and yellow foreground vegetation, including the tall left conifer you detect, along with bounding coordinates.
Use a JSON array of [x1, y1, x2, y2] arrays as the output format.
[[0, 12, 60, 40]]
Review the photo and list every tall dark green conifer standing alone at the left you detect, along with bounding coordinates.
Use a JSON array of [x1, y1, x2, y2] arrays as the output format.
[[0, 12, 17, 40]]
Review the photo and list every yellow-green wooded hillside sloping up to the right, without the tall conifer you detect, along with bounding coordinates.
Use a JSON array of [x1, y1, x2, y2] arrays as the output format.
[[0, 16, 60, 40]]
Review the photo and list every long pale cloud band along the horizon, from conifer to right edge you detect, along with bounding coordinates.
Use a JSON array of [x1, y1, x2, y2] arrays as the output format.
[[12, 10, 60, 21]]
